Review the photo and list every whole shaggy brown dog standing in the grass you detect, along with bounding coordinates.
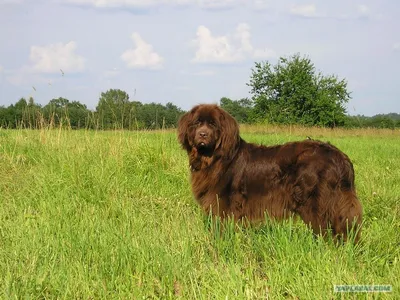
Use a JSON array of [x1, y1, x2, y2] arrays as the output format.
[[178, 104, 362, 241]]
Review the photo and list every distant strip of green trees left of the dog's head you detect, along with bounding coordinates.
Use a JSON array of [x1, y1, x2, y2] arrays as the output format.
[[0, 89, 184, 130]]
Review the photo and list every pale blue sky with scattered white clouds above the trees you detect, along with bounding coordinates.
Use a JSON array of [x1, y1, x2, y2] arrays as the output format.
[[0, 0, 400, 116]]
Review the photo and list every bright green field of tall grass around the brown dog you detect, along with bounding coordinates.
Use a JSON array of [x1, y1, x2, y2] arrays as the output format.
[[0, 126, 400, 299]]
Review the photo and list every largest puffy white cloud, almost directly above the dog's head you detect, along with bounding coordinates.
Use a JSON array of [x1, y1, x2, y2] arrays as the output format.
[[192, 23, 274, 63]]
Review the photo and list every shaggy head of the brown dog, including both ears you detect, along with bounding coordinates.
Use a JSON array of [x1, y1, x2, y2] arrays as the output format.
[[178, 104, 240, 157]]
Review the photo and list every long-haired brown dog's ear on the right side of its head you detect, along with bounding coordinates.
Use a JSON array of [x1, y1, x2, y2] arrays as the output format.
[[217, 108, 240, 159]]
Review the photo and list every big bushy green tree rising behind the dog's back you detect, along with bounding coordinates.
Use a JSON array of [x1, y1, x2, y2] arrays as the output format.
[[247, 54, 350, 127]]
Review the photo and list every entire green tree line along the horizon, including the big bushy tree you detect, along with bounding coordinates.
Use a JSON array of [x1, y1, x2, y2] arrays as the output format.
[[0, 54, 400, 129]]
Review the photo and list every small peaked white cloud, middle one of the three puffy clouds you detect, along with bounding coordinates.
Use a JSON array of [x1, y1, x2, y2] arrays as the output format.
[[121, 32, 164, 69]]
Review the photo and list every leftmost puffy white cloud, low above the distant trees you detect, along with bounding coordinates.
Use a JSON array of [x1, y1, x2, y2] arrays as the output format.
[[30, 41, 85, 73]]
